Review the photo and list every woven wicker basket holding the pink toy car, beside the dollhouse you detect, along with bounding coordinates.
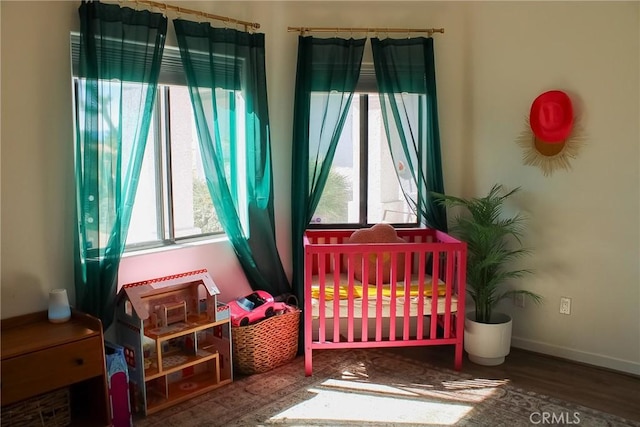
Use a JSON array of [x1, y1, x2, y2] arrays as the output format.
[[231, 308, 300, 374]]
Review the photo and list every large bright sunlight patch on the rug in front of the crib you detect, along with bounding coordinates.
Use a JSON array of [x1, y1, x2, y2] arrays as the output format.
[[270, 384, 473, 425]]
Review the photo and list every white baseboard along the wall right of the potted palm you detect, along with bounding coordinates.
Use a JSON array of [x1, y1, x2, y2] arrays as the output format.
[[511, 337, 640, 376]]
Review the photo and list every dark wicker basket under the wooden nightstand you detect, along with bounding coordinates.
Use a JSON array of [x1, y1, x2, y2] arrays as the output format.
[[2, 388, 71, 427]]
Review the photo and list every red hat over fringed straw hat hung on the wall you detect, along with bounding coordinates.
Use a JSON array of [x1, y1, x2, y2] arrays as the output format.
[[518, 90, 583, 176]]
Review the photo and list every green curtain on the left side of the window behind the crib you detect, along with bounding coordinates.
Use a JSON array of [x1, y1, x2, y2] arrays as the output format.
[[291, 36, 366, 310]]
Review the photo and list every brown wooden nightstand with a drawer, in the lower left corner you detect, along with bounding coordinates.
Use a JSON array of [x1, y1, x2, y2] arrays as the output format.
[[0, 311, 111, 426]]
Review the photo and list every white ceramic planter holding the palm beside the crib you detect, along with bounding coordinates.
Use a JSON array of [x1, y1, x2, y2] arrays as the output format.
[[464, 312, 512, 366]]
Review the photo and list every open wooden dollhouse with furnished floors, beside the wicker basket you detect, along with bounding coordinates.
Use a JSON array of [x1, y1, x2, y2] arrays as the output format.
[[116, 270, 233, 415]]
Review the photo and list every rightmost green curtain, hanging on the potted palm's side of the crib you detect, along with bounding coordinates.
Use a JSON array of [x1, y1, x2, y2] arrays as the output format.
[[371, 37, 447, 231]]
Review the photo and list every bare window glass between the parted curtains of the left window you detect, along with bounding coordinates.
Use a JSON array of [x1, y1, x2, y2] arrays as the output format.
[[127, 85, 223, 246]]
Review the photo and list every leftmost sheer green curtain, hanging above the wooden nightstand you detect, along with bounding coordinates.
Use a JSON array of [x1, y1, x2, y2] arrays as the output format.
[[74, 2, 167, 329]]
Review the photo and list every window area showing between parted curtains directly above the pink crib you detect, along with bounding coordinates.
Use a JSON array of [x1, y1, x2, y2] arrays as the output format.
[[310, 87, 417, 227]]
